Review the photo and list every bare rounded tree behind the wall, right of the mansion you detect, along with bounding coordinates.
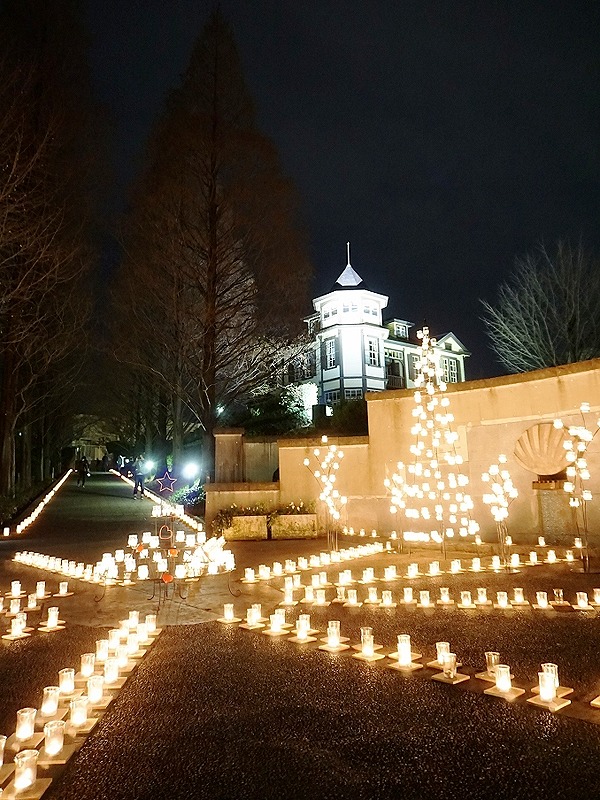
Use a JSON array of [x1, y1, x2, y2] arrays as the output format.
[[482, 242, 600, 372]]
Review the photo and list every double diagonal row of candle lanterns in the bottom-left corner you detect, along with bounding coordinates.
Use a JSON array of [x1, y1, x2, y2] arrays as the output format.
[[0, 611, 160, 797]]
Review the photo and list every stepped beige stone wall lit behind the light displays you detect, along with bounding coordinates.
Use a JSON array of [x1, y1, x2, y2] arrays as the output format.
[[207, 359, 600, 541]]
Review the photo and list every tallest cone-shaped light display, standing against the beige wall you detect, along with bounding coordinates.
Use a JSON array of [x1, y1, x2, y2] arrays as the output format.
[[386, 328, 479, 558]]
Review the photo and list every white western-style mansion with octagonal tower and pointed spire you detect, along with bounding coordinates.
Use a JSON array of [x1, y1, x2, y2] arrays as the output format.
[[284, 249, 470, 406]]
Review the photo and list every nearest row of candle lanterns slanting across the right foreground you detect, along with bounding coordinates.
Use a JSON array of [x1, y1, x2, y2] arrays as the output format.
[[219, 603, 600, 712]]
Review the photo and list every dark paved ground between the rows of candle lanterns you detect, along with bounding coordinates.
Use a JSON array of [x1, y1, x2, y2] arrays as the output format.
[[0, 475, 600, 800]]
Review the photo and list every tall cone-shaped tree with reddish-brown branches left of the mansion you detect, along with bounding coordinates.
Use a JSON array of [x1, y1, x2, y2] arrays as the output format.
[[116, 11, 310, 472]]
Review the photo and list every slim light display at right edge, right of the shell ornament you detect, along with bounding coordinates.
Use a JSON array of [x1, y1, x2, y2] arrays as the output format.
[[554, 403, 600, 572]]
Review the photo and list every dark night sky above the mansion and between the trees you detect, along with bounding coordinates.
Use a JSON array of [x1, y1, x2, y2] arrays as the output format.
[[88, 0, 600, 377]]
